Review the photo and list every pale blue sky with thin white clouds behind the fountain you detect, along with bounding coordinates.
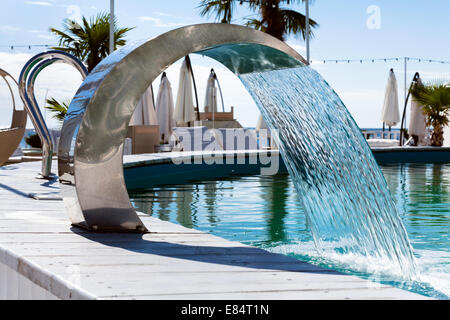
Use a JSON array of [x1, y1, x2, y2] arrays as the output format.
[[0, 0, 450, 127]]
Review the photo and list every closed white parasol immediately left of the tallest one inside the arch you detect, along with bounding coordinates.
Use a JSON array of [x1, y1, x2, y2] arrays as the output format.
[[156, 72, 175, 143]]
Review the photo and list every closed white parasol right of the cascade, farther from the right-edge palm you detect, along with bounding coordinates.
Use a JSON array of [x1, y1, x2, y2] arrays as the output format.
[[381, 69, 400, 130]]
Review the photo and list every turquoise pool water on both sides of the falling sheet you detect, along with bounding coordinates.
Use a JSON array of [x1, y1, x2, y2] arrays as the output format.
[[129, 164, 450, 298]]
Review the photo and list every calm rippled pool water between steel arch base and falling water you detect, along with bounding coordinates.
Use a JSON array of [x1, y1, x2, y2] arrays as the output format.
[[129, 175, 310, 246]]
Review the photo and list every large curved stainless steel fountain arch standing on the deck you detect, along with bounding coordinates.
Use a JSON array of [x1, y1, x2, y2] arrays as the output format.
[[58, 24, 306, 233]]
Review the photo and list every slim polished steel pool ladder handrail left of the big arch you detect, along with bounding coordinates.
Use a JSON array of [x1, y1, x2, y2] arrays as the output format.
[[19, 50, 88, 179]]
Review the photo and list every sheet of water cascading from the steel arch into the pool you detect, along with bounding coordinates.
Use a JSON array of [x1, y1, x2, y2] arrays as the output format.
[[239, 67, 418, 279]]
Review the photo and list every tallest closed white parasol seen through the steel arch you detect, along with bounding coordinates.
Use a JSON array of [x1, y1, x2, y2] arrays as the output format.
[[174, 59, 196, 126]]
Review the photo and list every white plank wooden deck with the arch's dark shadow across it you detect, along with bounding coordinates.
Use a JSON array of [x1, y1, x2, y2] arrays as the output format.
[[0, 162, 425, 300]]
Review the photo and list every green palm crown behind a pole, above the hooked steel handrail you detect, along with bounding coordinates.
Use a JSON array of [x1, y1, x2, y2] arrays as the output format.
[[50, 13, 134, 72]]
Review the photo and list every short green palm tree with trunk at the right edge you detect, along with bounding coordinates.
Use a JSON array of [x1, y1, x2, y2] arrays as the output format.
[[411, 83, 450, 147]]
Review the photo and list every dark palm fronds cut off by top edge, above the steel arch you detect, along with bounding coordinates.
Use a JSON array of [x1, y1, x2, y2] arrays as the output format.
[[200, 0, 318, 41]]
